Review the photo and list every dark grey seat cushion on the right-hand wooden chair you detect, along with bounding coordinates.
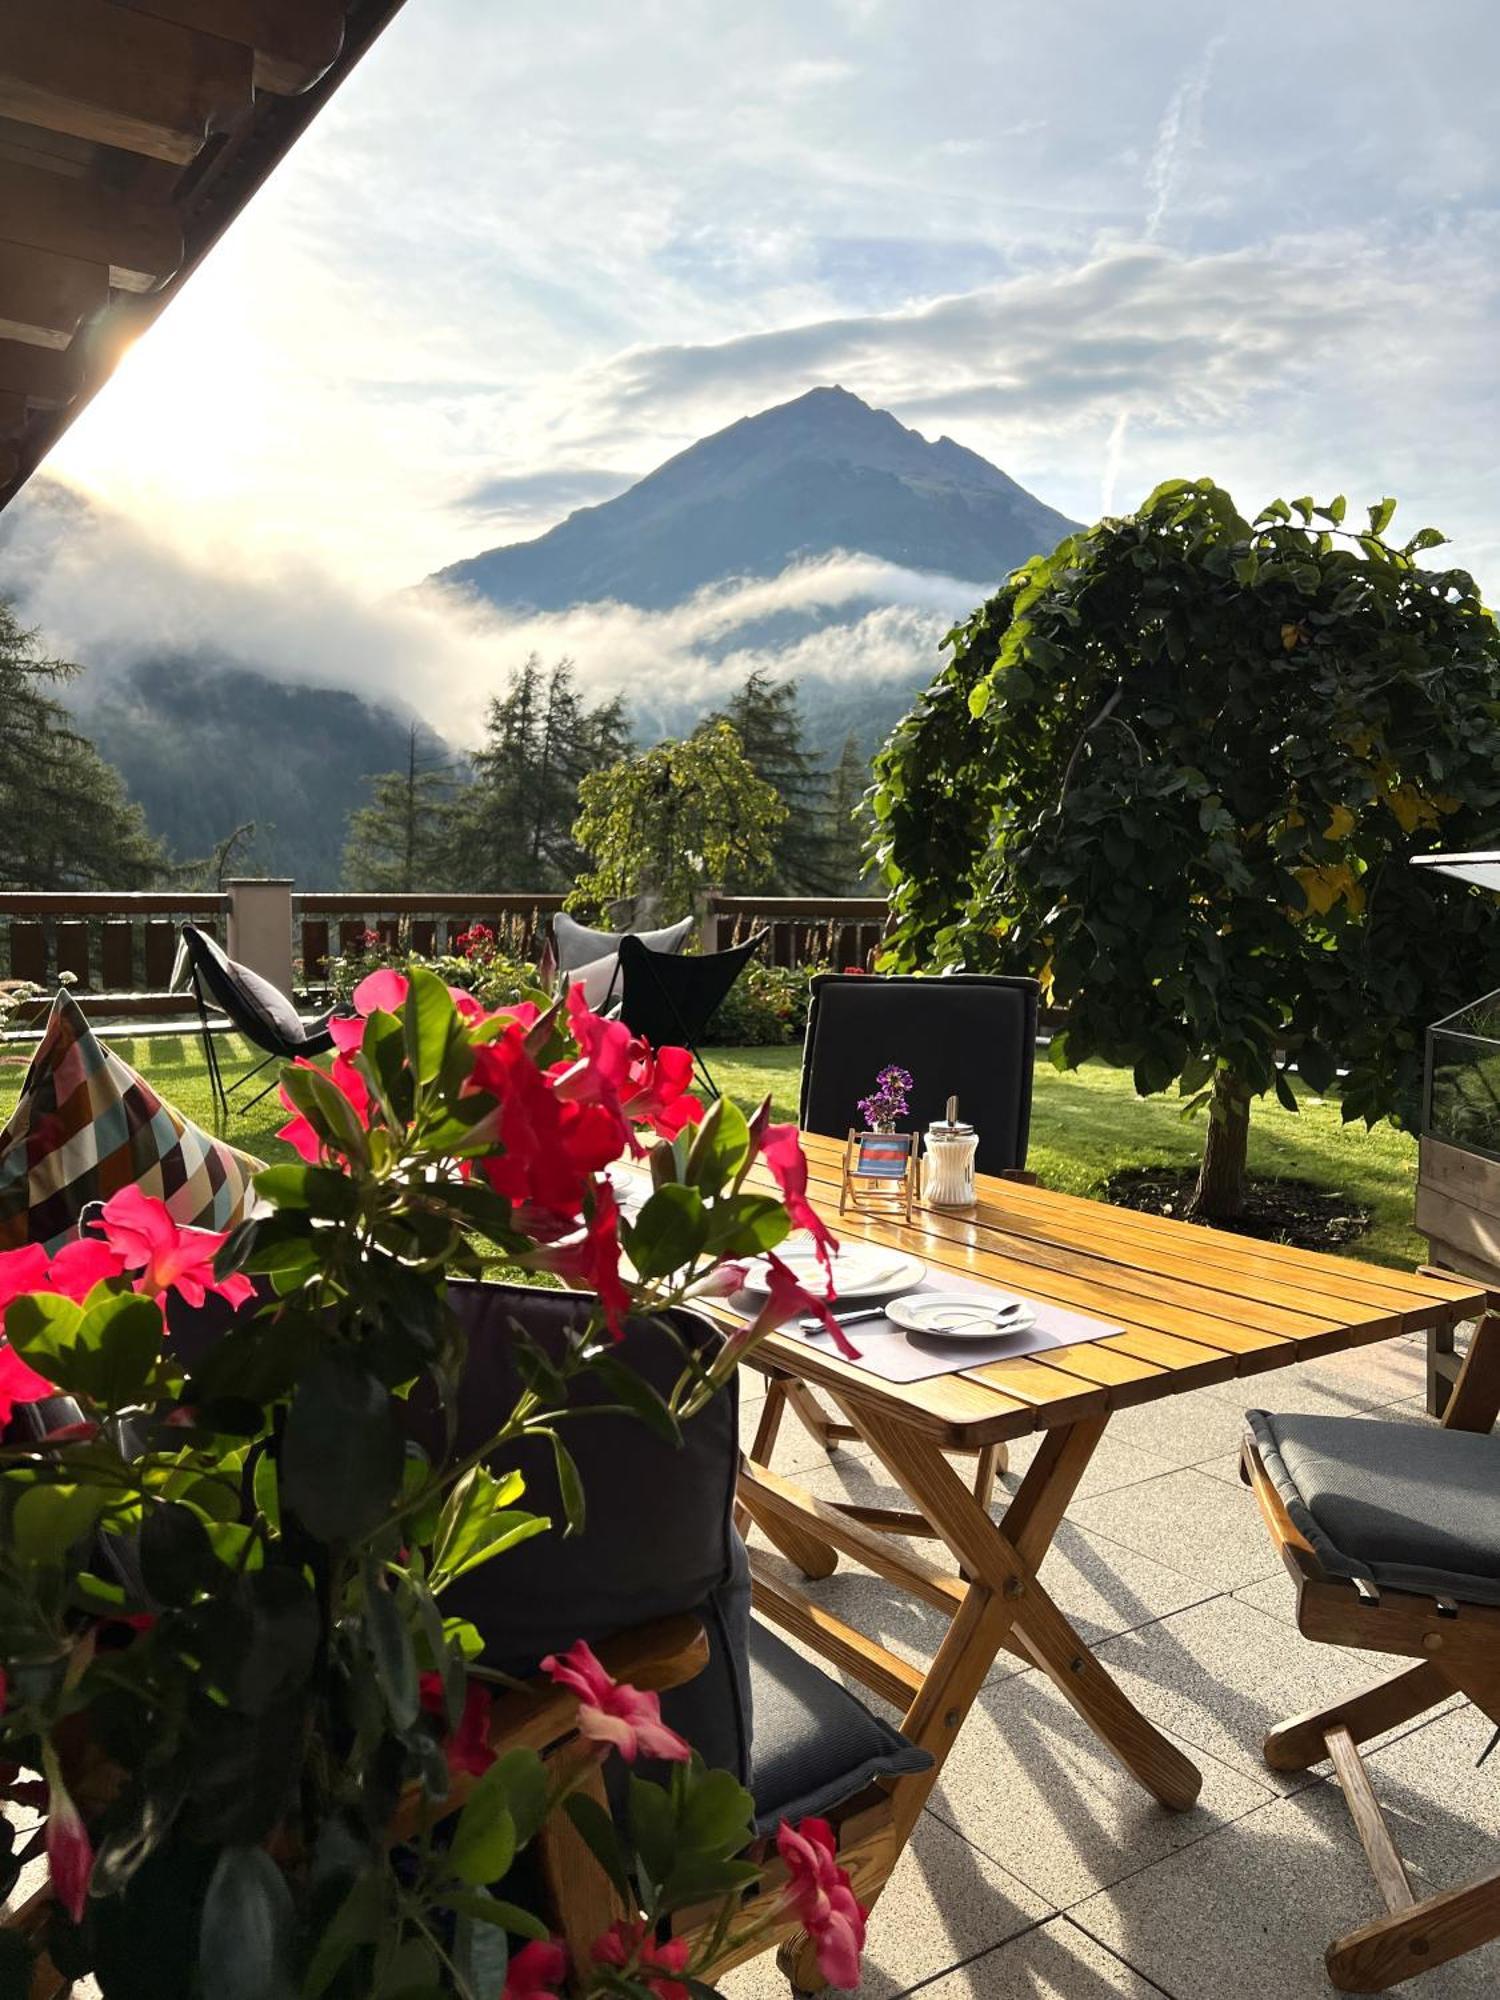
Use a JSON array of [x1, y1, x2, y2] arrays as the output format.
[[1248, 1410, 1500, 1604]]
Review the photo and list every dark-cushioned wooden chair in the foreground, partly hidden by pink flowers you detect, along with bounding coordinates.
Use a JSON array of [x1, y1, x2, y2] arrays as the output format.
[[4, 1284, 934, 2000]]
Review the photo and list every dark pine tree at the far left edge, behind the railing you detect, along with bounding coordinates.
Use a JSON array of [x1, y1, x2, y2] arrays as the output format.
[[0, 598, 166, 890]]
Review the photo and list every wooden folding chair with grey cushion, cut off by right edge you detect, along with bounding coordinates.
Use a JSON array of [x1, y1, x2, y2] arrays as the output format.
[[1242, 1314, 1500, 1994]]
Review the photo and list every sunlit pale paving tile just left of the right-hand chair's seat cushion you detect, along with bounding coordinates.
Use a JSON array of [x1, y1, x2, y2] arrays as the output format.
[[1070, 1466, 1282, 1594]]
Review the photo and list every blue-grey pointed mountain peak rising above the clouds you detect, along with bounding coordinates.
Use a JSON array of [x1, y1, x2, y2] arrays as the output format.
[[438, 382, 1074, 610]]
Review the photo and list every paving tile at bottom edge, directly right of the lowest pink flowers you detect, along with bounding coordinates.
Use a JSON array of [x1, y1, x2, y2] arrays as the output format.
[[718, 1812, 1048, 2000]]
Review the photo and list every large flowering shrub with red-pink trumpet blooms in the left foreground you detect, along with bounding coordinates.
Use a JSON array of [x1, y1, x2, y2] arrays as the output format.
[[0, 966, 862, 2000]]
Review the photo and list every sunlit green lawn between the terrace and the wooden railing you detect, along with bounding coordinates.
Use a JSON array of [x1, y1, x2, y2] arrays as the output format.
[[0, 1034, 1424, 1266]]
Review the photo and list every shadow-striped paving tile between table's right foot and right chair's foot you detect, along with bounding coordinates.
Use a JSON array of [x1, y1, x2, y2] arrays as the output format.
[[1098, 1578, 1412, 1792]]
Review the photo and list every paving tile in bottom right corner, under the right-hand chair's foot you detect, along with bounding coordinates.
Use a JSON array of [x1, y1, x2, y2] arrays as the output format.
[[1070, 1710, 1500, 2000]]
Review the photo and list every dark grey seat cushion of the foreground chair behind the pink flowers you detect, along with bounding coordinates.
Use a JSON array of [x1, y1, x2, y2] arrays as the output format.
[[750, 1618, 932, 1832]]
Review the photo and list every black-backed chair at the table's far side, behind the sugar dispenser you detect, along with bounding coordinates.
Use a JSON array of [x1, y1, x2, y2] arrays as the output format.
[[752, 972, 1038, 1526]]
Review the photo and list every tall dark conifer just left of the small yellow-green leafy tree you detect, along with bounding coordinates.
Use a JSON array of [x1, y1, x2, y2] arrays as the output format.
[[452, 654, 630, 890]]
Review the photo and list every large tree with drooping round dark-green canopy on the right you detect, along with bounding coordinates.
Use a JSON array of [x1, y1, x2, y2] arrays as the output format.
[[872, 480, 1500, 1216]]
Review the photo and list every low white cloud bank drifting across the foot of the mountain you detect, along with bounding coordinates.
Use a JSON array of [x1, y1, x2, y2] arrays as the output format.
[[0, 482, 986, 746]]
